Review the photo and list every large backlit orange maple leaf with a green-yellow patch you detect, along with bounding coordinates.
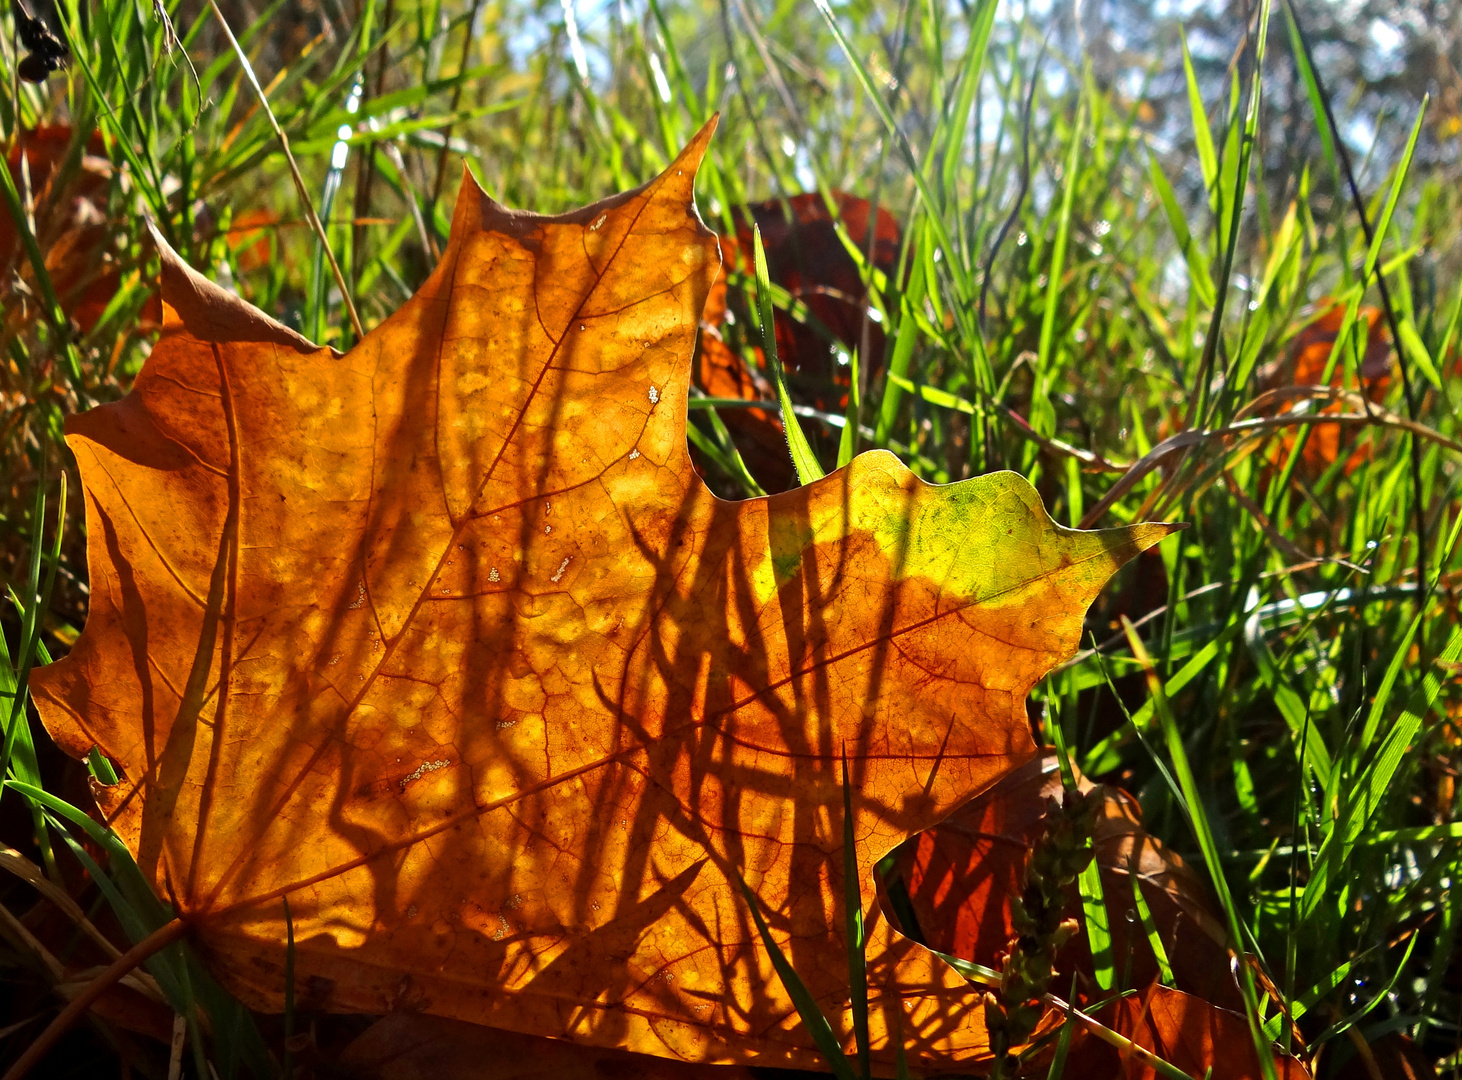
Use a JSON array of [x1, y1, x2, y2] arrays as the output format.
[[34, 126, 1174, 1068]]
